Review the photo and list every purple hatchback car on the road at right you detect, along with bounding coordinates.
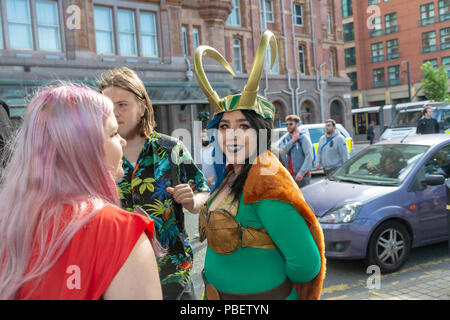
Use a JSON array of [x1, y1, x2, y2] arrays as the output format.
[[302, 134, 450, 273]]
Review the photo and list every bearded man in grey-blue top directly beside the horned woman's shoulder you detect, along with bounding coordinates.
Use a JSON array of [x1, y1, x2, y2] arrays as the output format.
[[278, 114, 313, 188]]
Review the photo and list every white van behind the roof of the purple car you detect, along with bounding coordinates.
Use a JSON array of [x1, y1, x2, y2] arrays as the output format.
[[380, 101, 450, 140]]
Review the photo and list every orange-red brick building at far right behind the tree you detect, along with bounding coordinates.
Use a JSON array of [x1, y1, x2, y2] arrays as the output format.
[[341, 0, 450, 108]]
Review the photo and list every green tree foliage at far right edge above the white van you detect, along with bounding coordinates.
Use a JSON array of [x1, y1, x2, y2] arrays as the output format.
[[420, 61, 450, 101]]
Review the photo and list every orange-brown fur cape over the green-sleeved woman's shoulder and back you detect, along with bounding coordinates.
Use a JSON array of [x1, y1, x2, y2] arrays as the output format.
[[244, 151, 326, 300]]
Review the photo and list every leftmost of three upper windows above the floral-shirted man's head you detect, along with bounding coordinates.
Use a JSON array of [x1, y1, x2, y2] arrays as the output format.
[[94, 7, 115, 54]]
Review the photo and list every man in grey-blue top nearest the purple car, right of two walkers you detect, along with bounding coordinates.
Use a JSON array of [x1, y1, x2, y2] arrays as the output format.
[[316, 119, 350, 176]]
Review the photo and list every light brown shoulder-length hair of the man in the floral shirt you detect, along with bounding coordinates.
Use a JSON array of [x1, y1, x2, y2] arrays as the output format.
[[97, 67, 156, 136]]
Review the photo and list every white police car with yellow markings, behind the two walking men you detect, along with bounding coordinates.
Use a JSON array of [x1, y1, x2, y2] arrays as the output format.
[[272, 123, 353, 170]]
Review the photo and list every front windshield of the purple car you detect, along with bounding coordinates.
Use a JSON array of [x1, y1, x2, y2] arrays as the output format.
[[330, 144, 429, 186]]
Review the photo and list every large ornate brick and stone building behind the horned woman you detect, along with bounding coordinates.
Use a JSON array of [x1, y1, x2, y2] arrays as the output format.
[[0, 0, 351, 133]]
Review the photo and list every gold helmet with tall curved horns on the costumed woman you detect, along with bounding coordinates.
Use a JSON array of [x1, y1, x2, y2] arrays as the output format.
[[194, 30, 277, 120]]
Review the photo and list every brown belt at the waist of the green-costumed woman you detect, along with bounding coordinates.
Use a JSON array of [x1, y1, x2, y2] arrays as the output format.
[[202, 272, 293, 300]]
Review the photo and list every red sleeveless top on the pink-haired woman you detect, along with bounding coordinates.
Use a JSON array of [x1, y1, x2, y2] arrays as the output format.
[[17, 206, 154, 300]]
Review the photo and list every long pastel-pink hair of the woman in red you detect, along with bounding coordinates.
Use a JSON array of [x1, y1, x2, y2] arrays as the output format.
[[0, 83, 119, 299]]
